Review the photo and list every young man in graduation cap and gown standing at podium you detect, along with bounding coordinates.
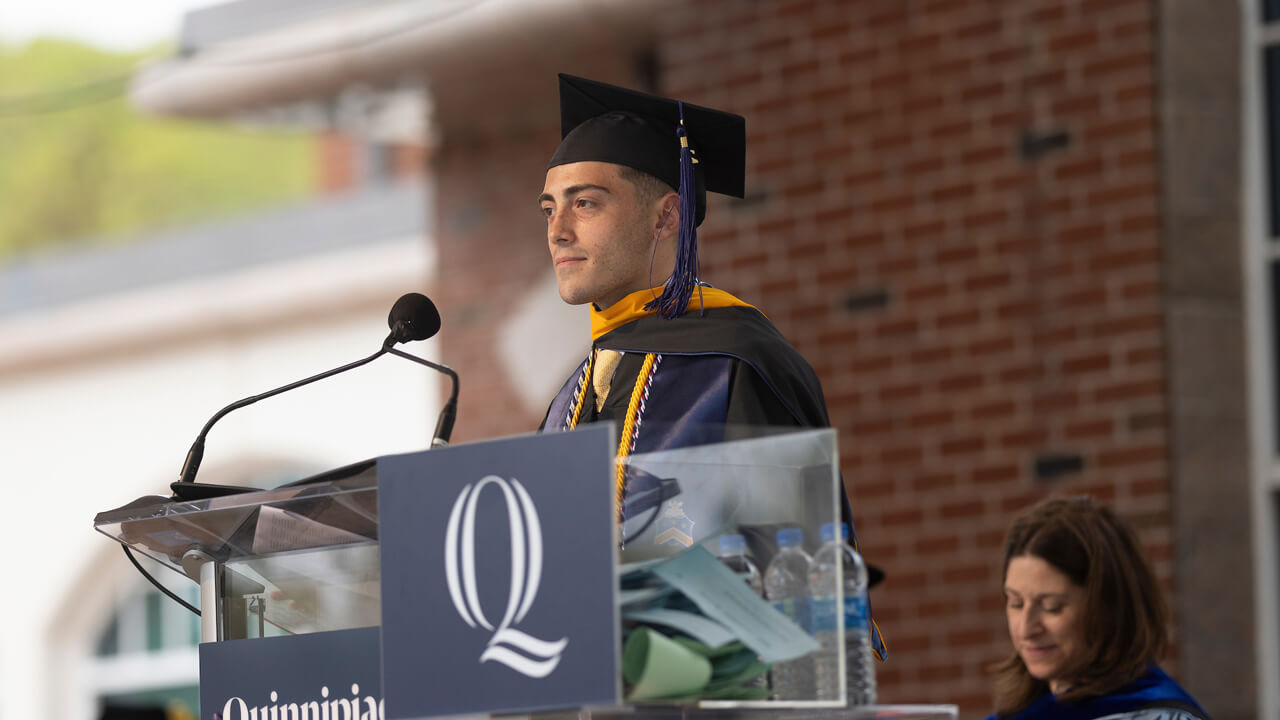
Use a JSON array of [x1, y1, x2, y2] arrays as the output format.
[[538, 74, 884, 659]]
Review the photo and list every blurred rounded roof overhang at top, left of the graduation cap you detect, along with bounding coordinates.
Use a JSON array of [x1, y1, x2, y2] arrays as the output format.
[[132, 0, 666, 137]]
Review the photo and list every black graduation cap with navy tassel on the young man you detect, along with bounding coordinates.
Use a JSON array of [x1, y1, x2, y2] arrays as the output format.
[[548, 73, 746, 316]]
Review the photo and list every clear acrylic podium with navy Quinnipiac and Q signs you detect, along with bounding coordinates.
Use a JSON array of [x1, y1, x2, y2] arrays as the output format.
[[95, 425, 956, 720]]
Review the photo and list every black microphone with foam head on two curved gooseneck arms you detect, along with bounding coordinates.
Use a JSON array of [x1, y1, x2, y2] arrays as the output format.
[[170, 292, 458, 486]]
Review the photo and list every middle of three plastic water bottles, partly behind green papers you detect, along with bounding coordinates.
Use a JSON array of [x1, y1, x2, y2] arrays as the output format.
[[764, 528, 814, 700]]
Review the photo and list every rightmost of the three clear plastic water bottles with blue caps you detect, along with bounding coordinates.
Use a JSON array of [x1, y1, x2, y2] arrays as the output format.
[[809, 523, 876, 706]]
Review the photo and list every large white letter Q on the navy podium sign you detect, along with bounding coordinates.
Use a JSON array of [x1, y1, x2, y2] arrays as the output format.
[[444, 475, 568, 678]]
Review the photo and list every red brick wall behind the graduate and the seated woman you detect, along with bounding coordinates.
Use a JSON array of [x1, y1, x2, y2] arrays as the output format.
[[435, 0, 1172, 717]]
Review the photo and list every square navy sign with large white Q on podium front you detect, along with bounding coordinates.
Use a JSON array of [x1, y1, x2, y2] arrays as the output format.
[[378, 428, 621, 719]]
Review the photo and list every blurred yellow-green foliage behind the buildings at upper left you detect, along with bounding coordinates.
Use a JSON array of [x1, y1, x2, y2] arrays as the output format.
[[0, 40, 316, 258]]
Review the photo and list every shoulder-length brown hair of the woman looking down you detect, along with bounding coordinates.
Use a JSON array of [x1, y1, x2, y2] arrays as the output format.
[[995, 497, 1169, 716]]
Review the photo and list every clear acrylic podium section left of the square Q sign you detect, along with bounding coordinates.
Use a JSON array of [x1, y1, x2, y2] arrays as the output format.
[[93, 453, 381, 642]]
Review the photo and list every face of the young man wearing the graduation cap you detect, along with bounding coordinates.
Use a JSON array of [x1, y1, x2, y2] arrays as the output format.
[[538, 163, 675, 309]]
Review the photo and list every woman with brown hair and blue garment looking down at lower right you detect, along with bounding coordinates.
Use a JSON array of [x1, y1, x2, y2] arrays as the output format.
[[988, 497, 1208, 720]]
